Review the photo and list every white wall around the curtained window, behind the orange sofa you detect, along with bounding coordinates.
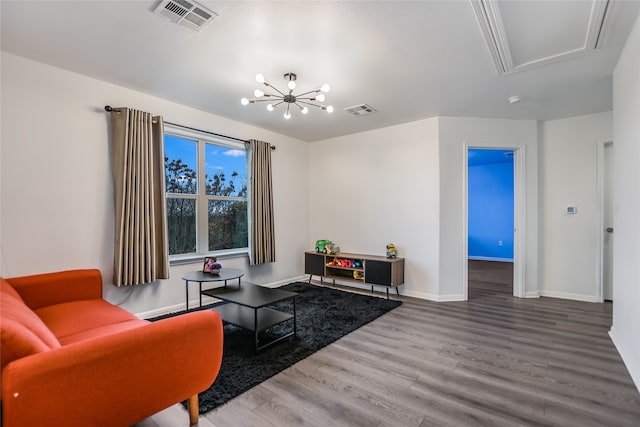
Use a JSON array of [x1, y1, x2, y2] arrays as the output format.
[[0, 52, 309, 313]]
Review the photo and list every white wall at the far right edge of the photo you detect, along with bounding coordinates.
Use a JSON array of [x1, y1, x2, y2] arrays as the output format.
[[611, 18, 640, 389]]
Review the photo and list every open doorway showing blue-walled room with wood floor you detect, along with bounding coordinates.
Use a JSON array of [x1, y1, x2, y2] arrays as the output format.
[[465, 147, 524, 300]]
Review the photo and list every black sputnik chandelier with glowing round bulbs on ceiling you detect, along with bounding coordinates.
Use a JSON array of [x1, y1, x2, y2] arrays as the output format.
[[240, 73, 333, 120]]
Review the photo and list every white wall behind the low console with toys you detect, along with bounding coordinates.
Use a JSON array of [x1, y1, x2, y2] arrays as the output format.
[[307, 118, 439, 299]]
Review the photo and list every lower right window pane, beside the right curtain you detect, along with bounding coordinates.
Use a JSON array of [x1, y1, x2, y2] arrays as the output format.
[[209, 200, 249, 251]]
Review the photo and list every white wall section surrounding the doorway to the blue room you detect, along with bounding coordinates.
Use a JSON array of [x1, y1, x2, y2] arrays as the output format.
[[439, 117, 538, 300]]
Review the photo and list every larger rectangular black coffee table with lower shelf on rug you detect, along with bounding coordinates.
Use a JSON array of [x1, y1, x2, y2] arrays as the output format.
[[202, 283, 298, 353]]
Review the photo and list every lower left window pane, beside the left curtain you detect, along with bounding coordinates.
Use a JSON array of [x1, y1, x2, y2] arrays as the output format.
[[167, 198, 196, 255]]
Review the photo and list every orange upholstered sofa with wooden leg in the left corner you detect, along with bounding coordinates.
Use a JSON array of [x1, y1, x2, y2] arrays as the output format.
[[0, 270, 223, 427]]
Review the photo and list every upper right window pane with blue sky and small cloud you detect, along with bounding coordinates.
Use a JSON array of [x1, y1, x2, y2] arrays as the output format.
[[204, 144, 247, 197]]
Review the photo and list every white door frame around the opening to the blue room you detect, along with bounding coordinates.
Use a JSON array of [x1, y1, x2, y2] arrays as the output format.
[[462, 142, 527, 301]]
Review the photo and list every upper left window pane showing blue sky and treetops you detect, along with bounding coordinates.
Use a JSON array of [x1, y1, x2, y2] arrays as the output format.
[[164, 135, 198, 194]]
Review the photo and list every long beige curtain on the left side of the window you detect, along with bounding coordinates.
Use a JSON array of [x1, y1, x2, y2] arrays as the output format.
[[111, 108, 169, 286]]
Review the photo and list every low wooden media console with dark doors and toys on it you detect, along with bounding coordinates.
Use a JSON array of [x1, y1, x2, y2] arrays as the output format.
[[304, 251, 404, 298]]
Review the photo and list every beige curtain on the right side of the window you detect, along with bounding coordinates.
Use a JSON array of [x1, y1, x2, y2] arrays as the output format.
[[249, 140, 276, 265]]
